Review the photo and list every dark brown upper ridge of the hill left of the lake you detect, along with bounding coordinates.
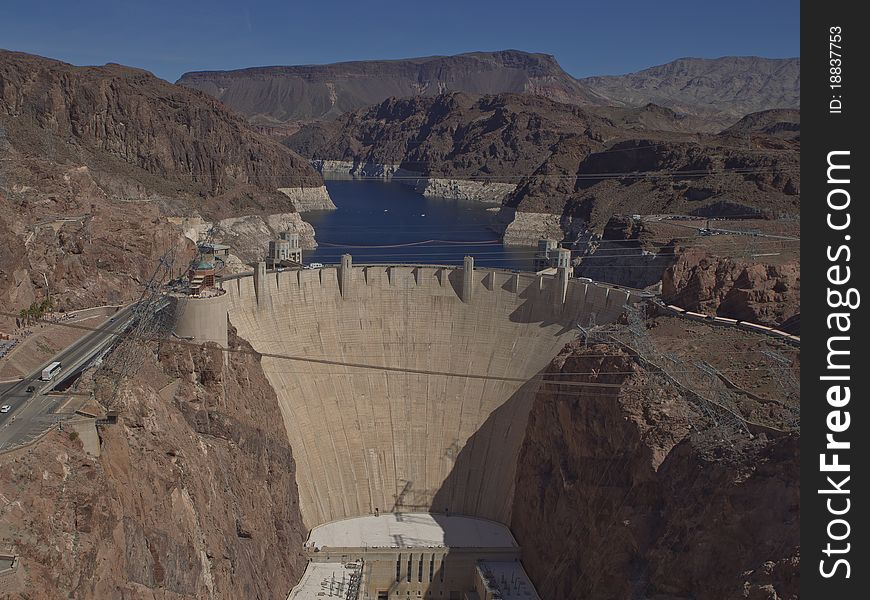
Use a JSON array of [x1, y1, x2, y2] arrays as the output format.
[[0, 51, 322, 195]]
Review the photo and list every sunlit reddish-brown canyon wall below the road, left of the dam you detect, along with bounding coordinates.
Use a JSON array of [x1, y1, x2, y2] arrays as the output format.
[[0, 332, 307, 600]]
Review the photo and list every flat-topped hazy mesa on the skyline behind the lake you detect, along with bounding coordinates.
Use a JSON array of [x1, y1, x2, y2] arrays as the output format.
[[177, 50, 596, 125]]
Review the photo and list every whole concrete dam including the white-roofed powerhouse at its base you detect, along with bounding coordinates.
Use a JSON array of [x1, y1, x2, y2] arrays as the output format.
[[176, 255, 639, 599]]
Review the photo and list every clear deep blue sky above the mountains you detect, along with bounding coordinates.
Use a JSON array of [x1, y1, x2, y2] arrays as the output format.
[[0, 0, 800, 81]]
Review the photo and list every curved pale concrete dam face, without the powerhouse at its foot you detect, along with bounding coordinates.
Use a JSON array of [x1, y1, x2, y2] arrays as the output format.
[[223, 264, 631, 528]]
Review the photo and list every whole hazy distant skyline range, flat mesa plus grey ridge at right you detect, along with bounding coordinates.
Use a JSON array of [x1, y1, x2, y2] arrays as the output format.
[[177, 50, 800, 131]]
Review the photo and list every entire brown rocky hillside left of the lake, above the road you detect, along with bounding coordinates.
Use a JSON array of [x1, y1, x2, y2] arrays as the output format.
[[0, 50, 334, 318]]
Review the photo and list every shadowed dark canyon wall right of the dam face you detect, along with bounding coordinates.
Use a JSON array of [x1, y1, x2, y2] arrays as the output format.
[[511, 343, 800, 600]]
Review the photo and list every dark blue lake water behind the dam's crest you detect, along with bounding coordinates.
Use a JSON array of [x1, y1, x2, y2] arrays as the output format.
[[302, 180, 534, 271]]
